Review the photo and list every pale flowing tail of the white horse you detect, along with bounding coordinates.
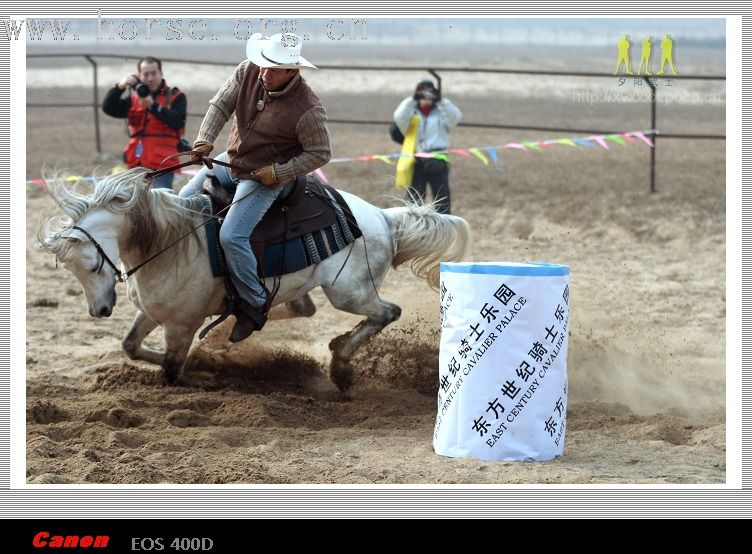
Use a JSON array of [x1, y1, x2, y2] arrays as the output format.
[[384, 204, 470, 288]]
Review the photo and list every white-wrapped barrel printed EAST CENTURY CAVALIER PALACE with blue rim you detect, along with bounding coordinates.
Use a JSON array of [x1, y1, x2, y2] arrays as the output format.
[[433, 262, 570, 461]]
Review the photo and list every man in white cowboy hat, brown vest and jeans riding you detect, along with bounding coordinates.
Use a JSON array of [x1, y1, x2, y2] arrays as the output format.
[[193, 33, 331, 342]]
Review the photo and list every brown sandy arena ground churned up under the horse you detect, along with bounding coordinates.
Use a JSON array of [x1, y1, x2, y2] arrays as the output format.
[[26, 47, 726, 483]]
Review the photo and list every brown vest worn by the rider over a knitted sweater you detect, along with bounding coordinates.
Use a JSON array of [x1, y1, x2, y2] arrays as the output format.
[[227, 64, 321, 179]]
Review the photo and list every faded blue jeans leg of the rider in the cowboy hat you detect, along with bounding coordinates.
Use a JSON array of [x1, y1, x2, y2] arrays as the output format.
[[219, 180, 282, 308]]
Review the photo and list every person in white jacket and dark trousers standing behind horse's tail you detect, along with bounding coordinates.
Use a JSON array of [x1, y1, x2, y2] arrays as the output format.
[[394, 81, 462, 214]]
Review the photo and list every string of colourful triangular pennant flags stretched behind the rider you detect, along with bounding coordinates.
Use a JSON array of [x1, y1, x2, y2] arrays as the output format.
[[26, 129, 660, 188]]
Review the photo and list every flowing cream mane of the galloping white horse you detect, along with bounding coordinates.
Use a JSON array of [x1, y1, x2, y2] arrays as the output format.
[[37, 168, 200, 261]]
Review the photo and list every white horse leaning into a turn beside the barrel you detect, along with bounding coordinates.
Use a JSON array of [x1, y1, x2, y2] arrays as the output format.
[[38, 169, 469, 391]]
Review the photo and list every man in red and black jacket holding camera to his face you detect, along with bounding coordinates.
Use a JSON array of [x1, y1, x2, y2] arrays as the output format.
[[102, 56, 190, 190]]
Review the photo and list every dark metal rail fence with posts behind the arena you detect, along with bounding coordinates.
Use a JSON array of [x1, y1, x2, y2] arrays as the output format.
[[26, 53, 726, 192]]
